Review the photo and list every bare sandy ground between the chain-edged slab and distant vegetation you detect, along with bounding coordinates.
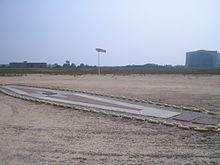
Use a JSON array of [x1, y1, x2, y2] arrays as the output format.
[[0, 75, 220, 111]]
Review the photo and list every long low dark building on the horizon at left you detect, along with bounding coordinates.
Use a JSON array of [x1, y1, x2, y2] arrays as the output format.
[[9, 61, 47, 68]]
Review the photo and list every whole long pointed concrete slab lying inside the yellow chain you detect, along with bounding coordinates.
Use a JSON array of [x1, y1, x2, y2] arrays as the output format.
[[1, 86, 180, 118]]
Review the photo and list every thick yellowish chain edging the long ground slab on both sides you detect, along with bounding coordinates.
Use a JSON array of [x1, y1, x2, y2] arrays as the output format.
[[0, 84, 220, 132]]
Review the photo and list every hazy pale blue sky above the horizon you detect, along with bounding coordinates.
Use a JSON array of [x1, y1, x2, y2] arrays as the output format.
[[0, 0, 220, 66]]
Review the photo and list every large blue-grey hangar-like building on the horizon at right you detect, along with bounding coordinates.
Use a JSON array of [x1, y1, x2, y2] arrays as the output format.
[[186, 50, 220, 68]]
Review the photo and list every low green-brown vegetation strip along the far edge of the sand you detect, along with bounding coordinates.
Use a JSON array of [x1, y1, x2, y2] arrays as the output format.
[[0, 65, 220, 76]]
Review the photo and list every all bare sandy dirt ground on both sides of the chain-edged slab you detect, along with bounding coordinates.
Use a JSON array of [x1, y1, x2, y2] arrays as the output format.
[[0, 74, 220, 165]]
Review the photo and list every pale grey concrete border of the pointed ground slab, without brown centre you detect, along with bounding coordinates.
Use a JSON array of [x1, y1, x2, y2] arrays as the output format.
[[3, 85, 180, 118]]
